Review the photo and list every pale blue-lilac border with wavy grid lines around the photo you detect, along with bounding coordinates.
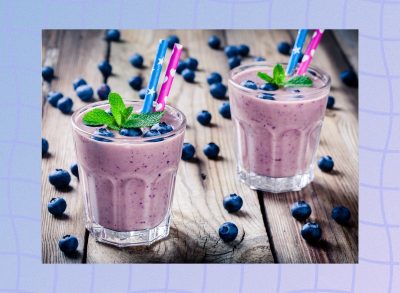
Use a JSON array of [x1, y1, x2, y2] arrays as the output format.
[[0, 0, 400, 293]]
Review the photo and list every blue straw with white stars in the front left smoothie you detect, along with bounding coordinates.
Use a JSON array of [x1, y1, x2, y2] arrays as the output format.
[[142, 40, 168, 113]]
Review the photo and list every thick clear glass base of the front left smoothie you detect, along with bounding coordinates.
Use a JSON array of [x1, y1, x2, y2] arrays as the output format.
[[86, 215, 170, 247]]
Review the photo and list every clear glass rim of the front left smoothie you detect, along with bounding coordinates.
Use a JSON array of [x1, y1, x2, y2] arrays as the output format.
[[71, 100, 187, 144]]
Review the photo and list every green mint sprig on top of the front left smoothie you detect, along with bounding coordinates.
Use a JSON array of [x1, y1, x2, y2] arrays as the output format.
[[82, 92, 165, 131]]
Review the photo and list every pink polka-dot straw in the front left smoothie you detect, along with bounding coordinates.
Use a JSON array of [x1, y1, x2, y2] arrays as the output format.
[[154, 43, 183, 111]]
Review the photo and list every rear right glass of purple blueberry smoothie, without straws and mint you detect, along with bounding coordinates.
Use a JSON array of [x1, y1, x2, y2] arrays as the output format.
[[229, 62, 330, 192]]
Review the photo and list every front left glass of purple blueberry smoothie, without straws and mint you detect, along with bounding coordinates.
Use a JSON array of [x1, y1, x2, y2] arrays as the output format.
[[72, 102, 186, 246]]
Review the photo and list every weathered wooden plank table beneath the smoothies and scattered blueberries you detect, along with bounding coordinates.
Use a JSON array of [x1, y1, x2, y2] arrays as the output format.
[[42, 30, 358, 263]]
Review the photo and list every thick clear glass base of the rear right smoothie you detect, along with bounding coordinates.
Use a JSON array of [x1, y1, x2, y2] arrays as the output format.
[[238, 166, 314, 193]]
